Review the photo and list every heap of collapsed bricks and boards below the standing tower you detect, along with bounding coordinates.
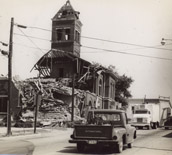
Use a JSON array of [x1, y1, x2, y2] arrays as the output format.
[[15, 79, 84, 125]]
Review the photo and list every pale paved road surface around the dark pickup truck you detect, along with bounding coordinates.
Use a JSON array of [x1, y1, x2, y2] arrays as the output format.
[[0, 129, 172, 155]]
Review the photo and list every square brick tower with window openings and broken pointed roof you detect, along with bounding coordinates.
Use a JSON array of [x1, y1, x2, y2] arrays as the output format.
[[51, 0, 82, 57]]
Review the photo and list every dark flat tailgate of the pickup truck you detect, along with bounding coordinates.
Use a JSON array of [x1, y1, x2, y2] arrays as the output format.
[[75, 125, 112, 139]]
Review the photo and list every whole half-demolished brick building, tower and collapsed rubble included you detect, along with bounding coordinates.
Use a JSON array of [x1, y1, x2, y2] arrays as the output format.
[[0, 0, 119, 126]]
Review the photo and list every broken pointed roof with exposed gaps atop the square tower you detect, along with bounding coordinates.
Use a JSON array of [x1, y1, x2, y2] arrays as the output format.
[[53, 0, 79, 20]]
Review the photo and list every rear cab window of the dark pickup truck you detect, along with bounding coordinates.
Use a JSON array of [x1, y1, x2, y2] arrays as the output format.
[[88, 111, 121, 125]]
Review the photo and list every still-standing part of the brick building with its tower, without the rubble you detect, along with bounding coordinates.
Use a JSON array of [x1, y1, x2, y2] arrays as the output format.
[[34, 0, 117, 109]]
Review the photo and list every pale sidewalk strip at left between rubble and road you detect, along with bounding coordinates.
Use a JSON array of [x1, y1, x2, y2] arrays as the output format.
[[0, 127, 70, 138]]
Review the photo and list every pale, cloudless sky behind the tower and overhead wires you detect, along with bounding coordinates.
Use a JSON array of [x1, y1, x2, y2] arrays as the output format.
[[0, 0, 172, 99]]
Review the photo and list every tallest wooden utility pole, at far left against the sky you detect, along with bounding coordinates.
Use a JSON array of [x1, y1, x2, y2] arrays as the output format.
[[7, 17, 14, 136]]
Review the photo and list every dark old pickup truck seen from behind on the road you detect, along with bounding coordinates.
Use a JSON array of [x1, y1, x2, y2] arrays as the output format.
[[69, 109, 136, 153]]
